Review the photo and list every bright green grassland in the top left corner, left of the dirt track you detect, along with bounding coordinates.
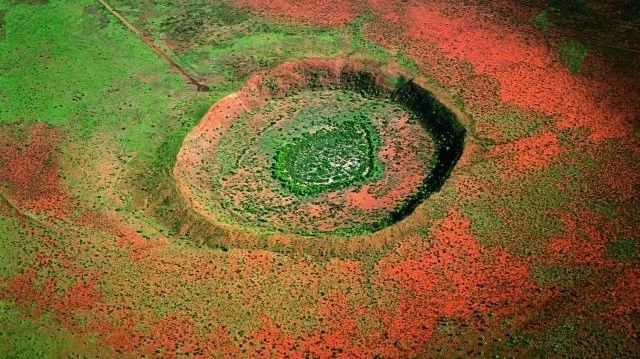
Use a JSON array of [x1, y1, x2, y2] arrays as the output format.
[[0, 1, 211, 155]]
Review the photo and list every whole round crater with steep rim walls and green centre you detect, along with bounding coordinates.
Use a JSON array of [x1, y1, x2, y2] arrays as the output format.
[[174, 59, 464, 234]]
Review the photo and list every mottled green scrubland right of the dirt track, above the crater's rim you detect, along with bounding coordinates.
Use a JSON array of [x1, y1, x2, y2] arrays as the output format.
[[115, 0, 350, 83]]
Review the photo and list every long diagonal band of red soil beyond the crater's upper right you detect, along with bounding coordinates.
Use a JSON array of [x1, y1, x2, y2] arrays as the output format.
[[402, 4, 637, 141]]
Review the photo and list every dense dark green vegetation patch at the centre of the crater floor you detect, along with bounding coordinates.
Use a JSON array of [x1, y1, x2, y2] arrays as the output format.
[[273, 116, 379, 195]]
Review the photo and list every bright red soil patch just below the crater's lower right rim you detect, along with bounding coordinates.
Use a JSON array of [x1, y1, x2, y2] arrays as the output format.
[[378, 212, 536, 351]]
